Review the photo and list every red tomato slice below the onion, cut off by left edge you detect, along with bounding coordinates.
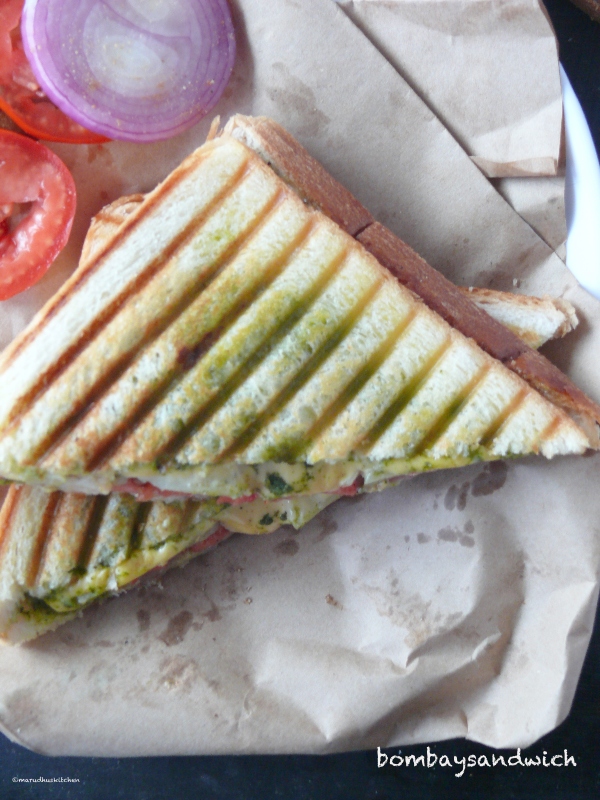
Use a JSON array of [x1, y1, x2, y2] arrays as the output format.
[[0, 131, 76, 300]]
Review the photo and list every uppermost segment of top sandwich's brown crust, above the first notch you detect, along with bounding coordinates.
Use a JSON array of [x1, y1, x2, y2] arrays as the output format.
[[231, 117, 373, 236]]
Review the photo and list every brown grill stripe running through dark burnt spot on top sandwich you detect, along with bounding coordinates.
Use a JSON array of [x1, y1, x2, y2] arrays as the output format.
[[86, 217, 318, 470]]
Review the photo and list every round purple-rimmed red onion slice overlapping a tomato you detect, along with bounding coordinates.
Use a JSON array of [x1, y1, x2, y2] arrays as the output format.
[[21, 0, 235, 142]]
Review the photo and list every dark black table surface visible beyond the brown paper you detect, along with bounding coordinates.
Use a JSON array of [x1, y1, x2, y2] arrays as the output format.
[[0, 0, 600, 800]]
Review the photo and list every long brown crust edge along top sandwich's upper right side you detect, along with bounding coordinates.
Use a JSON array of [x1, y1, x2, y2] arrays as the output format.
[[223, 115, 600, 434]]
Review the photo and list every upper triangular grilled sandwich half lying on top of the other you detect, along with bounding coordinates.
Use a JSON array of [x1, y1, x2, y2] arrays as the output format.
[[0, 118, 600, 501]]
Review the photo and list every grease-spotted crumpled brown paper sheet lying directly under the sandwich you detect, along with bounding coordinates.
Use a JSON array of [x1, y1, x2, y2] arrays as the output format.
[[0, 0, 600, 756]]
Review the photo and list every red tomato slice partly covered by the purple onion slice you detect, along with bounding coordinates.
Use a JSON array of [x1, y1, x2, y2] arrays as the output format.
[[0, 0, 108, 144]]
